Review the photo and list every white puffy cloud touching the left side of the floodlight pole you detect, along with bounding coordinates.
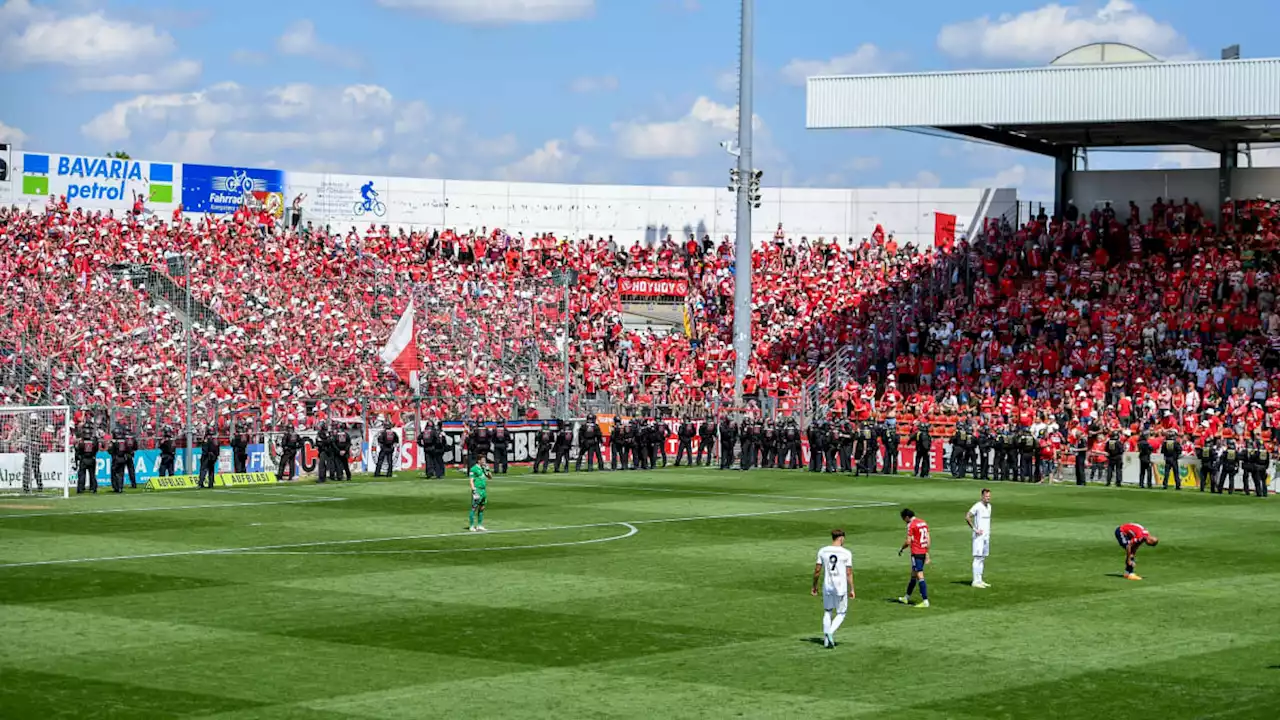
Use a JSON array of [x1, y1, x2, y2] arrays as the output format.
[[613, 97, 763, 159]]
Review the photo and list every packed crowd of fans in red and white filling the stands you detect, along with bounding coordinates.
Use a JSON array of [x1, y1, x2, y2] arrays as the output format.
[[0, 188, 1280, 466]]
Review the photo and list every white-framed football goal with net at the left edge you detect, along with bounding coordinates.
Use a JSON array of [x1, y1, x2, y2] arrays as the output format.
[[0, 406, 74, 497]]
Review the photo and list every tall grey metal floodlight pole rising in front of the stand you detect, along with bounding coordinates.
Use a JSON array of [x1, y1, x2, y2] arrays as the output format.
[[733, 0, 755, 407]]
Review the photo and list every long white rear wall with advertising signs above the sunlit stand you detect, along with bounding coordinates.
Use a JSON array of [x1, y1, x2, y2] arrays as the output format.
[[0, 151, 1018, 246]]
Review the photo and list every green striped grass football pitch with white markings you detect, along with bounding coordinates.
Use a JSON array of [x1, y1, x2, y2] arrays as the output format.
[[0, 461, 1280, 720]]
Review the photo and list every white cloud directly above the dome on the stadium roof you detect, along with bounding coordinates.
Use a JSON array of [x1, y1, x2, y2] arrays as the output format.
[[937, 0, 1189, 63]]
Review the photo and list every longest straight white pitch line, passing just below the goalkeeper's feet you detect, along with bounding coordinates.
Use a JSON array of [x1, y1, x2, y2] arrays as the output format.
[[0, 502, 897, 569]]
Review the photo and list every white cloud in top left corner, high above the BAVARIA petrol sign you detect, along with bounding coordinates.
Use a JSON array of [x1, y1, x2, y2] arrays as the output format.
[[0, 6, 175, 67]]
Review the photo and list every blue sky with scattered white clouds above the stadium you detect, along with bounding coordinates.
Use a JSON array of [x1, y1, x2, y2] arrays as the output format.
[[0, 0, 1280, 197]]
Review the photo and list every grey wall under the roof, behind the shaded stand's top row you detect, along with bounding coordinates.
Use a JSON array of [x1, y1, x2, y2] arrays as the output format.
[[1069, 168, 1280, 220]]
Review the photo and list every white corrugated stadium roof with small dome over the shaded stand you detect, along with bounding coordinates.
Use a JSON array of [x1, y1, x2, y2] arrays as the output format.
[[806, 51, 1280, 156]]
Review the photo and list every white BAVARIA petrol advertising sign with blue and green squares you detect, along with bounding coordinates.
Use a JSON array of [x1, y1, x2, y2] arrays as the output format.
[[13, 152, 175, 210]]
